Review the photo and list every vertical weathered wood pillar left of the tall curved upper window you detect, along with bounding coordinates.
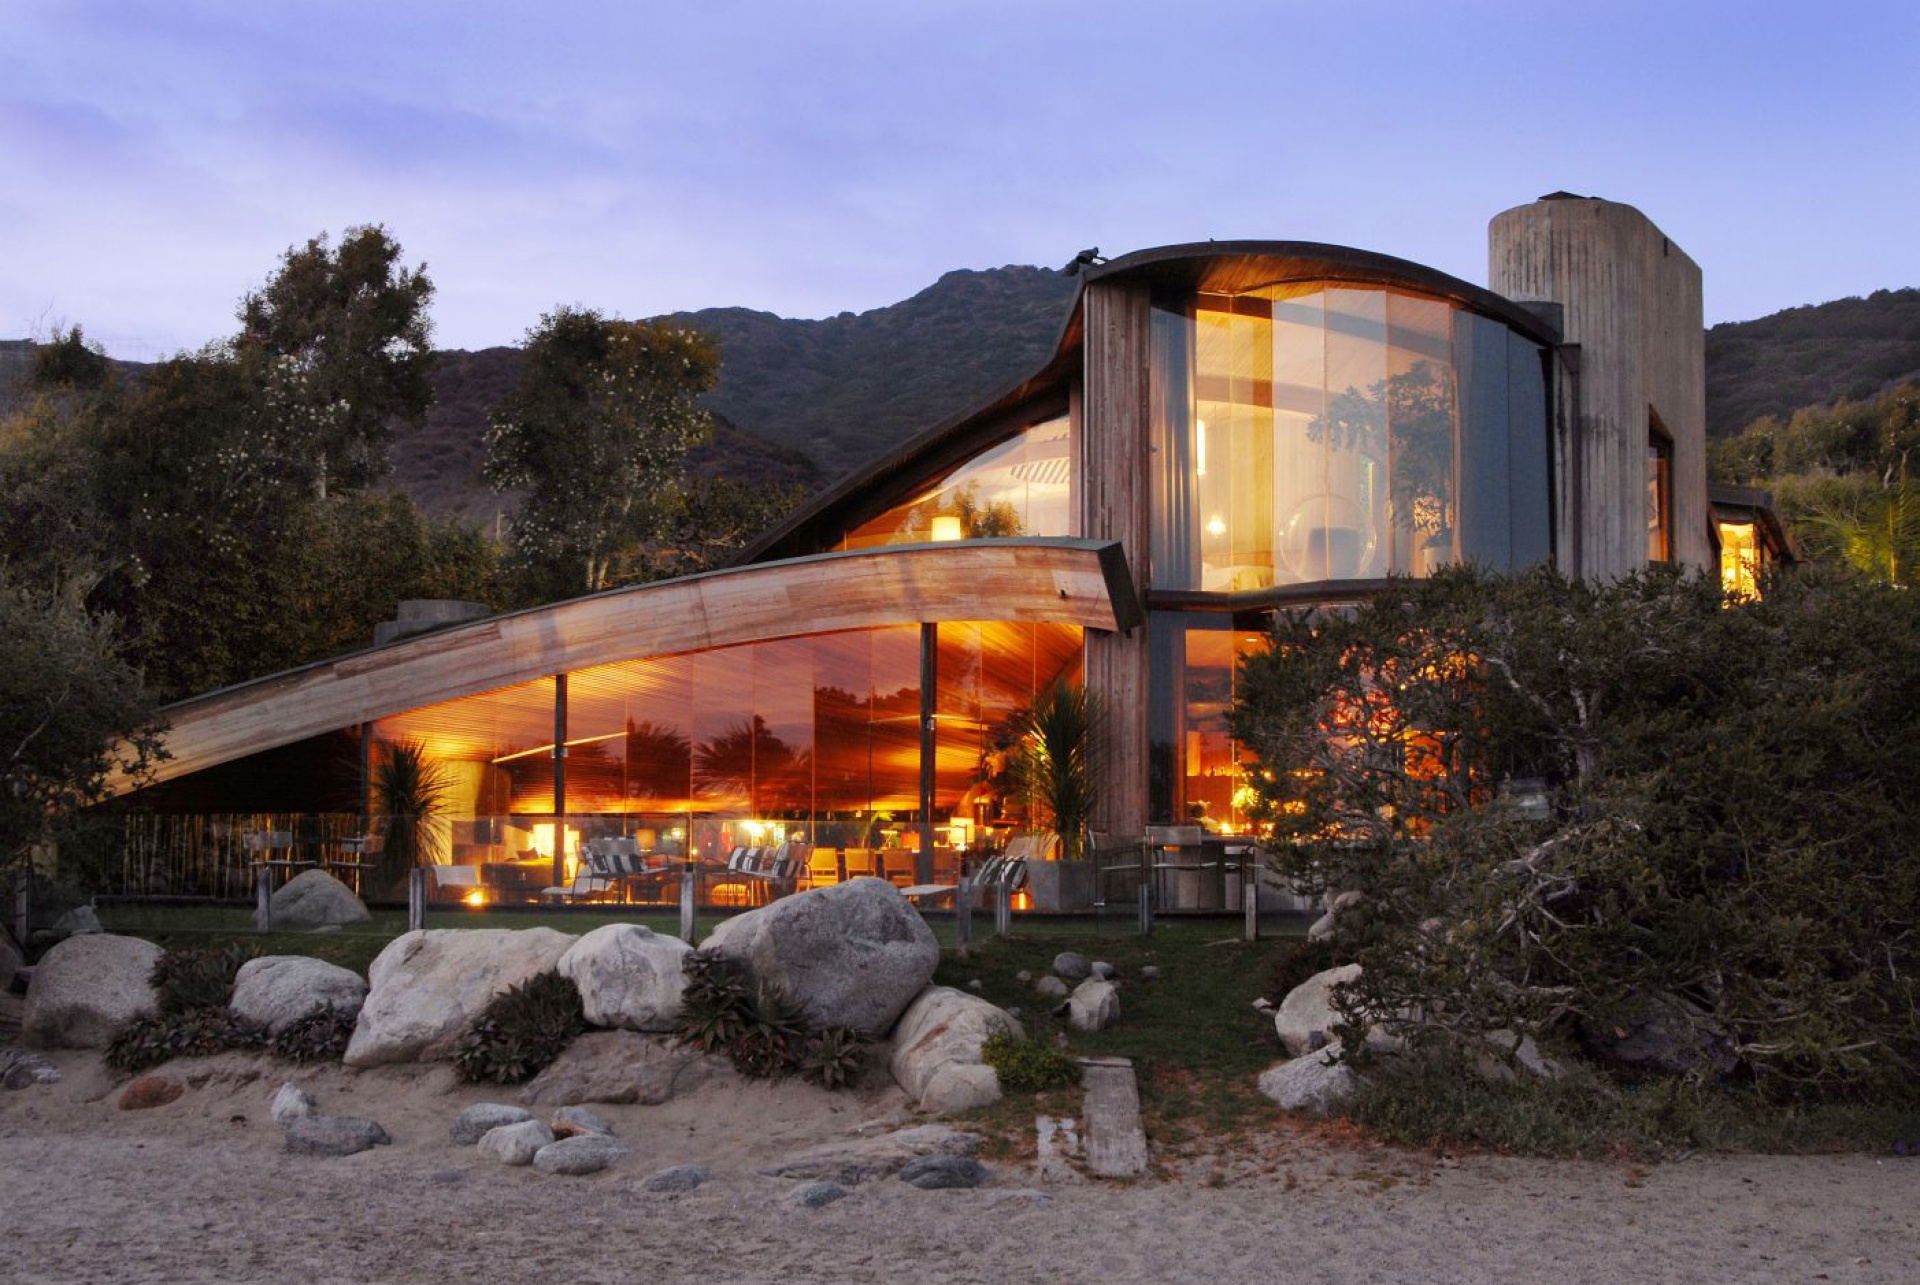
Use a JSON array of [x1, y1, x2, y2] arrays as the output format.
[[1077, 282, 1152, 836]]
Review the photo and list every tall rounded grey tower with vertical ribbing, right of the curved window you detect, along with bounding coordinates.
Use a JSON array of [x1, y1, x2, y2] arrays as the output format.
[[1490, 198, 1711, 578]]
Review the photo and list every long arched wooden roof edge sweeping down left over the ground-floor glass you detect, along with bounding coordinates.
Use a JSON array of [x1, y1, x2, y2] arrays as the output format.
[[115, 540, 1140, 789]]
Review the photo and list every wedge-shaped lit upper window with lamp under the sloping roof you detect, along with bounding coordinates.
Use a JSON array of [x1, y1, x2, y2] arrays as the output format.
[[835, 415, 1073, 549]]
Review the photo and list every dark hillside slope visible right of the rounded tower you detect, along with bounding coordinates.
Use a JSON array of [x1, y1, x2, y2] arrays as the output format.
[[1707, 288, 1920, 438]]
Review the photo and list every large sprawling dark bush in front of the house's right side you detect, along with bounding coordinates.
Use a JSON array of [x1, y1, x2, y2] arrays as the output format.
[[1235, 569, 1920, 1097]]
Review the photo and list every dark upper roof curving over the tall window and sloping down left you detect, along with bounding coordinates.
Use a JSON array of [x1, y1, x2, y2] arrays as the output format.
[[735, 240, 1559, 565]]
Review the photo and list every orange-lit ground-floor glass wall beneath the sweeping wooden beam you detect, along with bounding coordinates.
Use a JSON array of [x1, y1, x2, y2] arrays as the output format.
[[362, 622, 1081, 901]]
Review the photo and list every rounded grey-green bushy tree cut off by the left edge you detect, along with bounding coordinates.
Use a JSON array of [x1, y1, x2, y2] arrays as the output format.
[[0, 576, 165, 866]]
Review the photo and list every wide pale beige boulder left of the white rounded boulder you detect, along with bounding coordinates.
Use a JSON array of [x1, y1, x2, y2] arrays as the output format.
[[344, 928, 576, 1066]]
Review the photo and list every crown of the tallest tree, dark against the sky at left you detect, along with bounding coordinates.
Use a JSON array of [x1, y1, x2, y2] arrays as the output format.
[[232, 225, 434, 499]]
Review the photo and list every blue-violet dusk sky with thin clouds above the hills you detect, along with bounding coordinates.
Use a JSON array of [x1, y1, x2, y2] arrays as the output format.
[[0, 0, 1920, 359]]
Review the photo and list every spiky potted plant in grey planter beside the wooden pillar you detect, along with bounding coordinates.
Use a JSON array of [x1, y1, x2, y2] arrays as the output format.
[[1012, 680, 1104, 910]]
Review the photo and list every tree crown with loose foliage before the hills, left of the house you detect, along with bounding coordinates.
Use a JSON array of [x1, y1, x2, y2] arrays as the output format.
[[486, 307, 720, 594]]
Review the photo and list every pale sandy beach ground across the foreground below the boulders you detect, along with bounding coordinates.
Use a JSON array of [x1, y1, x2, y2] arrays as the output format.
[[0, 1055, 1920, 1285]]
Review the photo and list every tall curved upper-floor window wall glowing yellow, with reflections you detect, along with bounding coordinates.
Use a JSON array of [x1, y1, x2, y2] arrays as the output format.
[[1152, 282, 1551, 594]]
